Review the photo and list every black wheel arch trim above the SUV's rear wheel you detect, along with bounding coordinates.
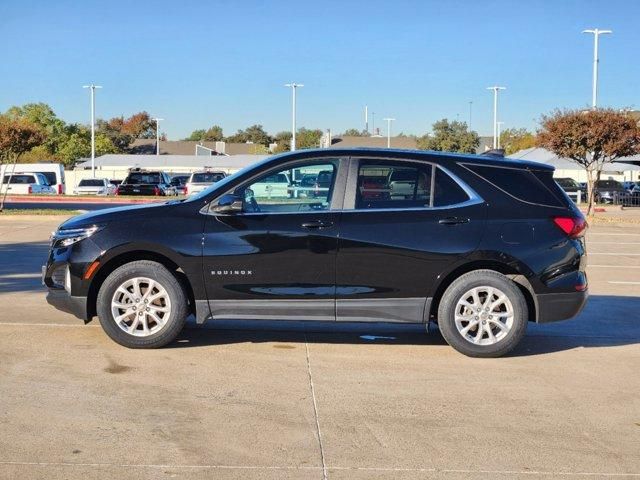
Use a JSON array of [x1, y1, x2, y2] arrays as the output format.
[[429, 260, 538, 322]]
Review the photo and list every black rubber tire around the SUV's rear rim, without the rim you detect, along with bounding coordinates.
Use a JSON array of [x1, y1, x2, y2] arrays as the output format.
[[438, 270, 529, 358]]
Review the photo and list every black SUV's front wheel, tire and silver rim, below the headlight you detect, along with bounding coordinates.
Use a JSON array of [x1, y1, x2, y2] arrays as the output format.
[[96, 260, 188, 348]]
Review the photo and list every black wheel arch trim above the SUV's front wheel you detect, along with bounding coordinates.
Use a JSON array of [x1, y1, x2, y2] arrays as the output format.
[[87, 249, 195, 321]]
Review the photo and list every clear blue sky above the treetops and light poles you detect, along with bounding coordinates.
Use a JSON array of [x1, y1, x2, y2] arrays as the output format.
[[0, 0, 640, 139]]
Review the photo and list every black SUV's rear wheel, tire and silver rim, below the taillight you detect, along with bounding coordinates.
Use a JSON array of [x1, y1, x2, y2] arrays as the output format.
[[438, 270, 528, 357]]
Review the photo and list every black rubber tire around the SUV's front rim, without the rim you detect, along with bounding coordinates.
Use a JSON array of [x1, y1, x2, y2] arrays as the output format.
[[96, 260, 189, 348]]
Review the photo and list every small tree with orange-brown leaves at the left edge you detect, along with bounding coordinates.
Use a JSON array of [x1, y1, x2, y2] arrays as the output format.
[[0, 115, 46, 212]]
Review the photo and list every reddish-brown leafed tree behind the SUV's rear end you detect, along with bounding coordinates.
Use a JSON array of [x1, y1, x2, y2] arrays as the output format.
[[538, 109, 640, 216]]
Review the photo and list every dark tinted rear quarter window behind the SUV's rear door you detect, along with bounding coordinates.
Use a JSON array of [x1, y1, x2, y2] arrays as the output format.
[[465, 165, 566, 207]]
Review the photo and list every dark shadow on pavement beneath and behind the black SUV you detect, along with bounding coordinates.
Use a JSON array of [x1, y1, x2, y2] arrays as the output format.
[[168, 295, 640, 357]]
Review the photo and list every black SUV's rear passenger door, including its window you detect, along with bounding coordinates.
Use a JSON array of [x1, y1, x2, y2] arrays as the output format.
[[336, 158, 486, 322]]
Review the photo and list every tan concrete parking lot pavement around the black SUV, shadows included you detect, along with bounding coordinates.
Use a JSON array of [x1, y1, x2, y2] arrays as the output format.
[[0, 217, 640, 479]]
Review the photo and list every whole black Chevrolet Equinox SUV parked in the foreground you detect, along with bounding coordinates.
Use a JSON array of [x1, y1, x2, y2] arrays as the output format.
[[43, 149, 587, 357]]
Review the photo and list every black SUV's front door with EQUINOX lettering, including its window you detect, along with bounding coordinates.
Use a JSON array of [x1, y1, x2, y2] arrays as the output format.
[[203, 158, 346, 321]]
